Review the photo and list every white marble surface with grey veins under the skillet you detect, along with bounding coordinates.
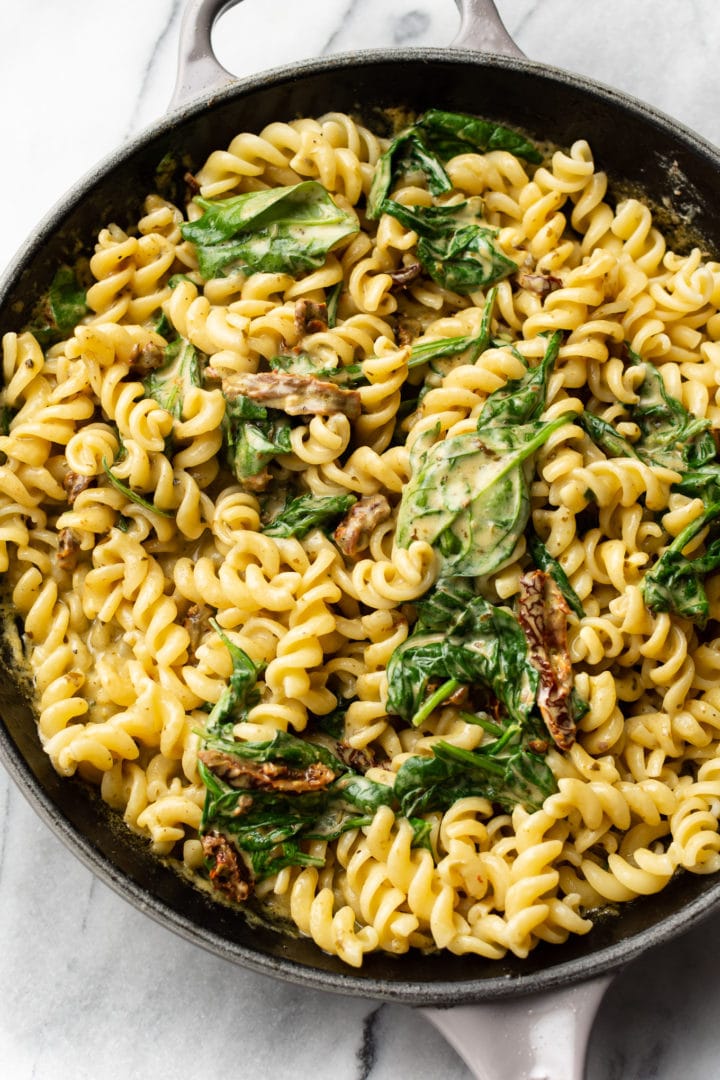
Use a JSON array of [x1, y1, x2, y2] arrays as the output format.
[[0, 0, 720, 1080]]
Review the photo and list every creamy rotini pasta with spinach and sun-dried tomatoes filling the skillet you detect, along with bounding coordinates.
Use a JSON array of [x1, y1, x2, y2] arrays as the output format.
[[0, 105, 720, 967]]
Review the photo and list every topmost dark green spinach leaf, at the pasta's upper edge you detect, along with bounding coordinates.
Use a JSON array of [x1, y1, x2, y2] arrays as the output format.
[[416, 109, 542, 164]]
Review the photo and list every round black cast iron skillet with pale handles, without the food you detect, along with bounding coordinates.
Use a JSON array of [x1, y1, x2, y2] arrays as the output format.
[[0, 0, 720, 1076]]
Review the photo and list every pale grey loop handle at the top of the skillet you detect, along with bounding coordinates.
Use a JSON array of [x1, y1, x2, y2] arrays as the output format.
[[168, 0, 524, 112]]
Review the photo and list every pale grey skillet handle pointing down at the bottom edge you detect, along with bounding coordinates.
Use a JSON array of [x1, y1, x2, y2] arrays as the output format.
[[420, 975, 611, 1080]]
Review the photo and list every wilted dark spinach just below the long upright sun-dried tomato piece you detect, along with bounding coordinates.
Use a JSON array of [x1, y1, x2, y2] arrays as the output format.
[[395, 731, 557, 818]]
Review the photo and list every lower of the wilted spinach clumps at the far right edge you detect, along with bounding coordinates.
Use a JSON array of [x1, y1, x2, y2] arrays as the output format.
[[640, 502, 720, 629]]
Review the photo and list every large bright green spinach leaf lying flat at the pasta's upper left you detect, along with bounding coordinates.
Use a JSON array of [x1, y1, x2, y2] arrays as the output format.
[[181, 180, 358, 280]]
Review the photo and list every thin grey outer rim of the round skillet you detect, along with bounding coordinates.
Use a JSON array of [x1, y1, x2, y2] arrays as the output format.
[[0, 42, 720, 1005]]
